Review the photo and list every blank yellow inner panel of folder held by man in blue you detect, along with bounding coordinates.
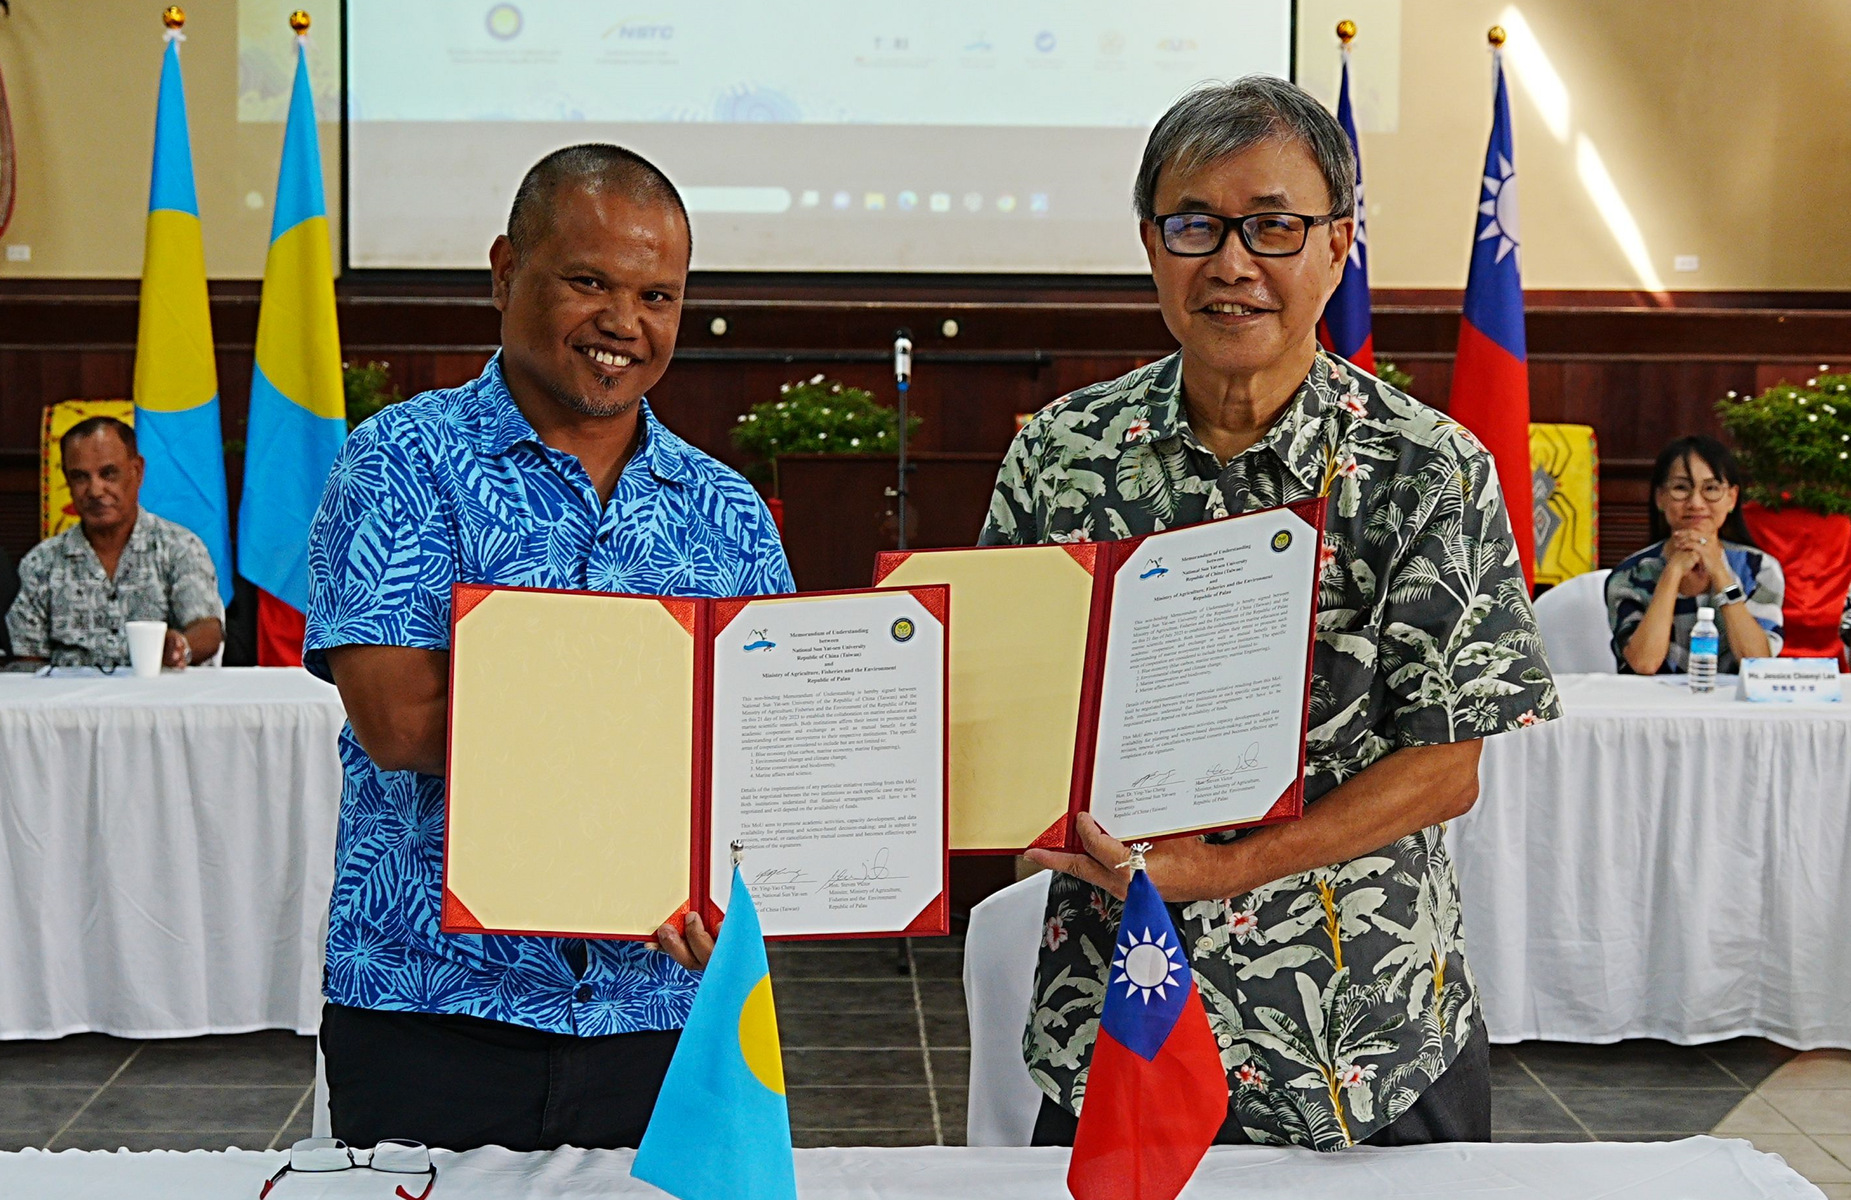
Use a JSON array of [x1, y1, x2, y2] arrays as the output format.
[[448, 591, 694, 937]]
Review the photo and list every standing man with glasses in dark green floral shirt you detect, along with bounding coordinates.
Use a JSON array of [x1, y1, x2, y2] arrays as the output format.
[[983, 76, 1559, 1150]]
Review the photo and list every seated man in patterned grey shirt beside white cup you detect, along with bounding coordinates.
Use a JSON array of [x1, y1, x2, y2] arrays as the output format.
[[6, 417, 226, 670]]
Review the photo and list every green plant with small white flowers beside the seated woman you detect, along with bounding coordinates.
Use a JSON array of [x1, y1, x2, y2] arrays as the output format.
[[1716, 374, 1851, 515]]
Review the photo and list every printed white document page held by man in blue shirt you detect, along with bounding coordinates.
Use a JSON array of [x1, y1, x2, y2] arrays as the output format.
[[709, 591, 946, 935]]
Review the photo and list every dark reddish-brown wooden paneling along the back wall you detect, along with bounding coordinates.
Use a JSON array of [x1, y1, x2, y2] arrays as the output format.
[[0, 288, 1851, 574]]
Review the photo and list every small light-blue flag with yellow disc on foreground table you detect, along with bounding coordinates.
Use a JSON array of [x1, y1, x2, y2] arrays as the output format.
[[629, 867, 798, 1200]]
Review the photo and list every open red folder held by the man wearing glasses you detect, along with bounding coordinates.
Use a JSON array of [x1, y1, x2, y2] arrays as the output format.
[[876, 500, 1325, 854]]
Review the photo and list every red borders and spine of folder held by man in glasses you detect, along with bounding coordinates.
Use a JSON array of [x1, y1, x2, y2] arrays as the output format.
[[874, 498, 1325, 854]]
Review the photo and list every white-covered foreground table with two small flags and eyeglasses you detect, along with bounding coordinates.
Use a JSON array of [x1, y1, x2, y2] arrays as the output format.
[[0, 1137, 1823, 1200]]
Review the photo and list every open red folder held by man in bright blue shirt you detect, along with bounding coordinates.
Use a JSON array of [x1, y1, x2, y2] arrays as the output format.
[[442, 583, 950, 939]]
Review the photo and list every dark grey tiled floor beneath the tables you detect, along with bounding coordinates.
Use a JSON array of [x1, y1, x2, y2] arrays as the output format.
[[0, 939, 1851, 1200]]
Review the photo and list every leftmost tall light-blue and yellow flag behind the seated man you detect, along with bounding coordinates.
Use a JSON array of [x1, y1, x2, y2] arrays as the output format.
[[135, 31, 231, 602]]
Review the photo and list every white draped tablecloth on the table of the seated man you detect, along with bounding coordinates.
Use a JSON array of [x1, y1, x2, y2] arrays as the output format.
[[0, 669, 344, 1037]]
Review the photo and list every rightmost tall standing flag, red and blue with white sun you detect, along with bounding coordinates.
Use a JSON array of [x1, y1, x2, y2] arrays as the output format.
[[1447, 50, 1536, 580]]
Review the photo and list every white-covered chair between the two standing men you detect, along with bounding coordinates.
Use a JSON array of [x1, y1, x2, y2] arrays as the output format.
[[964, 870, 1051, 1146]]
